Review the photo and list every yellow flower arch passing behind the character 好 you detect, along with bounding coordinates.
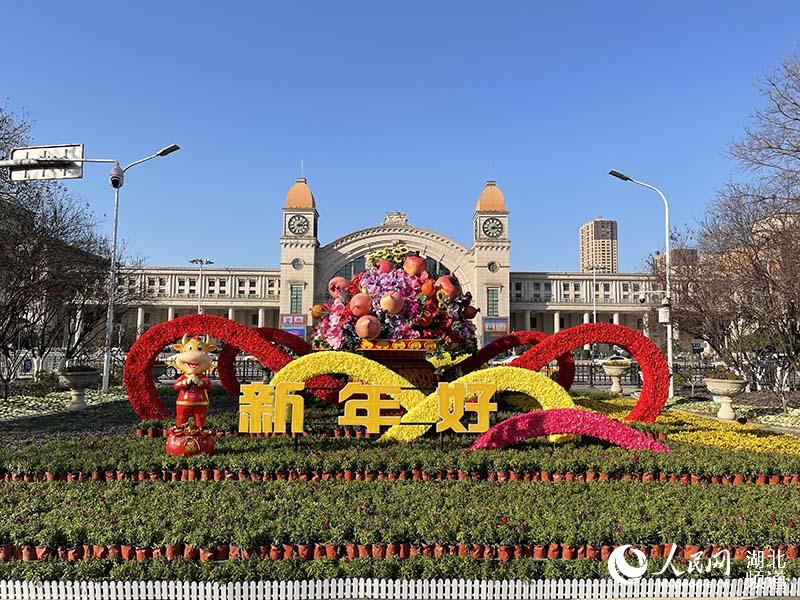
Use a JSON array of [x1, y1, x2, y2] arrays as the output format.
[[381, 367, 575, 442]]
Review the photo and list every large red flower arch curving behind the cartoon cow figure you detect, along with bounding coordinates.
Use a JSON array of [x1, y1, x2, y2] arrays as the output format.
[[124, 315, 339, 419]]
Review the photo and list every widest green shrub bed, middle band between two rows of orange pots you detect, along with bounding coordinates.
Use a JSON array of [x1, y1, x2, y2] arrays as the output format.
[[0, 482, 800, 558]]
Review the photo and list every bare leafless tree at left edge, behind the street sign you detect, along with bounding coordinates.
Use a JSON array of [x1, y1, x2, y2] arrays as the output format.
[[0, 107, 141, 397]]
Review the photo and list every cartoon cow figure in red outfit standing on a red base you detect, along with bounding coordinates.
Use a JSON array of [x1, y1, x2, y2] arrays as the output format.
[[172, 334, 217, 429]]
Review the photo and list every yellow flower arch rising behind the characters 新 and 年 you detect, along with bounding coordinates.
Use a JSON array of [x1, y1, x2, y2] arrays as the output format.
[[271, 350, 425, 410]]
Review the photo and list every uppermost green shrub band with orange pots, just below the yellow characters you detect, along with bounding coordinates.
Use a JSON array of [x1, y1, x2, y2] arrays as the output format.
[[0, 434, 800, 483]]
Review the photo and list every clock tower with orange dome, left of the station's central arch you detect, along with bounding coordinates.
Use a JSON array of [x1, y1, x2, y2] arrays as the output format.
[[280, 177, 319, 324]]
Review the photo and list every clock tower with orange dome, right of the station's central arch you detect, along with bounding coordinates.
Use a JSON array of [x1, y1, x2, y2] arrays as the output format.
[[472, 179, 511, 343]]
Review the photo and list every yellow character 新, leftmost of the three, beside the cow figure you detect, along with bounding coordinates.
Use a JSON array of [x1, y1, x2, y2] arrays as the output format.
[[239, 381, 305, 433]]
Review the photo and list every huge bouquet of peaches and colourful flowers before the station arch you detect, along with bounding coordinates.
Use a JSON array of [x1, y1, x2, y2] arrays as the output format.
[[311, 245, 478, 353]]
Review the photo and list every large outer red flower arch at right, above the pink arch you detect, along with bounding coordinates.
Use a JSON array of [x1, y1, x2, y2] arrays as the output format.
[[511, 323, 670, 423]]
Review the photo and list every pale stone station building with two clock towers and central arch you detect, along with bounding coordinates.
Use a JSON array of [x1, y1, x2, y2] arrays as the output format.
[[119, 178, 651, 339]]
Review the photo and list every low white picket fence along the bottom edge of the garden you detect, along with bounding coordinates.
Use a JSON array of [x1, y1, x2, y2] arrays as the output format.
[[0, 578, 800, 600]]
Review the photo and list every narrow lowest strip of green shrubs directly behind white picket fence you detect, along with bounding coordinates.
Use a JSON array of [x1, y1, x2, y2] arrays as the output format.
[[0, 556, 800, 582]]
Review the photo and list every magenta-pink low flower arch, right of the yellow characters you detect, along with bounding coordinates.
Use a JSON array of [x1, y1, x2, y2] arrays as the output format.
[[470, 408, 669, 452]]
